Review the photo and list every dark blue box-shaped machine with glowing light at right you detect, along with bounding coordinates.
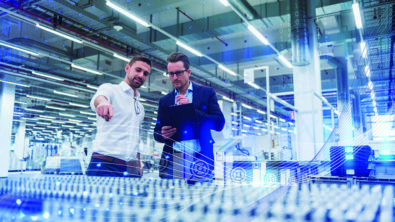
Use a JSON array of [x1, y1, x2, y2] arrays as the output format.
[[330, 146, 372, 177]]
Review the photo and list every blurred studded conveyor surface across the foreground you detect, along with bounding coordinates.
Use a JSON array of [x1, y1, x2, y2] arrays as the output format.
[[0, 174, 394, 222]]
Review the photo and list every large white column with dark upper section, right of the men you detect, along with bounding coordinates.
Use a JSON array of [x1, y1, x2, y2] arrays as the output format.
[[291, 0, 323, 161]]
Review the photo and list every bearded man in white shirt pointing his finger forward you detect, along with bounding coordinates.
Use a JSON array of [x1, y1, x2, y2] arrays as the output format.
[[86, 56, 152, 177]]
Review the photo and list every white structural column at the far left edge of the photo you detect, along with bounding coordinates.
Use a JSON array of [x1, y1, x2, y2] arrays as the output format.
[[0, 83, 15, 177]]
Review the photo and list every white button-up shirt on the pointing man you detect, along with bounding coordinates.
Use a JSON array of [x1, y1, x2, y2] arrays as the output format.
[[90, 81, 144, 161]]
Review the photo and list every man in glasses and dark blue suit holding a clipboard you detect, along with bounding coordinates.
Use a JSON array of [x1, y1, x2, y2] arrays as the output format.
[[154, 52, 225, 183]]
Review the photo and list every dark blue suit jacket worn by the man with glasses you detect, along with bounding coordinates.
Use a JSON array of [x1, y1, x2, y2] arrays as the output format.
[[154, 82, 225, 178]]
